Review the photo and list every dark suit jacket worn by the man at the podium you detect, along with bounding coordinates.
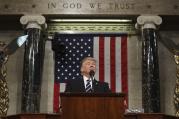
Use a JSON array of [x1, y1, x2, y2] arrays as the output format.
[[65, 76, 111, 93]]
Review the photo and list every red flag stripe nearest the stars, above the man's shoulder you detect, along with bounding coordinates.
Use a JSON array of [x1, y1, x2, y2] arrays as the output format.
[[99, 37, 105, 81]]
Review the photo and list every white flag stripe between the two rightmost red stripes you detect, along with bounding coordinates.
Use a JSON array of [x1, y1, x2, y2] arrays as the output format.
[[115, 37, 122, 92]]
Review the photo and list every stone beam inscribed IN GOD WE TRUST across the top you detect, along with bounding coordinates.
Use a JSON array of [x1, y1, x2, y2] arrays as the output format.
[[0, 0, 179, 15]]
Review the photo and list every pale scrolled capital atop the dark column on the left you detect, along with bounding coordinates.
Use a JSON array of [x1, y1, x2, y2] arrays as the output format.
[[20, 15, 46, 29]]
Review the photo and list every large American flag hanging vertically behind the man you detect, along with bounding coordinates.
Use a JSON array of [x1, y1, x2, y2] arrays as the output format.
[[52, 34, 128, 112]]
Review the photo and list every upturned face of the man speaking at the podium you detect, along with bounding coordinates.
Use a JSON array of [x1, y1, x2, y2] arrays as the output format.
[[81, 59, 96, 76]]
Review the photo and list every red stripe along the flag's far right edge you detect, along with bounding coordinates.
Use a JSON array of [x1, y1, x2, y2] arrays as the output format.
[[121, 36, 128, 94]]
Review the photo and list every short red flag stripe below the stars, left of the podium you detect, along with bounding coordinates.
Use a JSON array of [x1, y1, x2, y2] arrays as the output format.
[[53, 82, 60, 112]]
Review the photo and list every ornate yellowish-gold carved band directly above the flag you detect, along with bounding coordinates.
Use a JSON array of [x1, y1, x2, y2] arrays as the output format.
[[47, 23, 136, 36]]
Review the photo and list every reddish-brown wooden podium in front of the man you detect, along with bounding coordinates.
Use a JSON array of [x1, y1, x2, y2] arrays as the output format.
[[60, 93, 125, 119]]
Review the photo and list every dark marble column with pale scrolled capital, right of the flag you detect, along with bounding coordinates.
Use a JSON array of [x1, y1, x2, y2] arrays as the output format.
[[137, 16, 162, 113]]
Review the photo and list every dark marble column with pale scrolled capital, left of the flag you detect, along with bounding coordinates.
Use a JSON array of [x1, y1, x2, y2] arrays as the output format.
[[20, 15, 45, 113]]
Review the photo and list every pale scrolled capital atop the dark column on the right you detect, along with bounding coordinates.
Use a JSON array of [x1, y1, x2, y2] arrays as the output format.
[[136, 15, 162, 29]]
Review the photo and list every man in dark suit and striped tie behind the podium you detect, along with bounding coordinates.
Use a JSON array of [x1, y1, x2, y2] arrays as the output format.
[[65, 57, 111, 93]]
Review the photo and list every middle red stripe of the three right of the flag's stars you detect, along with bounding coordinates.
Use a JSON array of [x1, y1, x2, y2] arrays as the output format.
[[110, 37, 116, 92]]
